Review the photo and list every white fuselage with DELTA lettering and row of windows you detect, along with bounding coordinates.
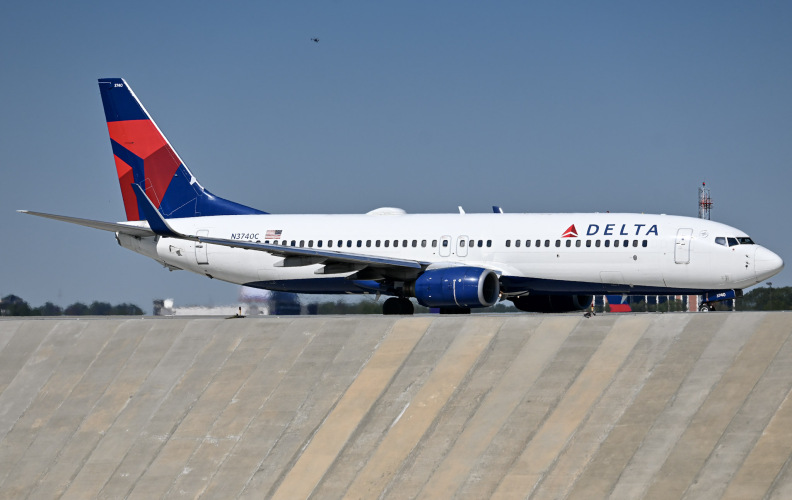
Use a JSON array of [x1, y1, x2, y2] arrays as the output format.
[[119, 213, 783, 295]]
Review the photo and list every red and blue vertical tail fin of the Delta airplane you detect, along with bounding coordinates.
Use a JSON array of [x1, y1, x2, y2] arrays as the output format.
[[99, 78, 265, 220]]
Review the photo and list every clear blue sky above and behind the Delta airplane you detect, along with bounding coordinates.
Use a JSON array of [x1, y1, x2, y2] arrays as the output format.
[[0, 0, 792, 311]]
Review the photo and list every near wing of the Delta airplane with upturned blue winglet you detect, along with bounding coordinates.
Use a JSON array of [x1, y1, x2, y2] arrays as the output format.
[[132, 184, 430, 269]]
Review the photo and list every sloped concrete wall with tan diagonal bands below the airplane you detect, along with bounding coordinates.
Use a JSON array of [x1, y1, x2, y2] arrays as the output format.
[[0, 312, 792, 499]]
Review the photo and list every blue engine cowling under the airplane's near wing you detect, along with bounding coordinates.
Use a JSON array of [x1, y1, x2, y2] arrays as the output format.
[[410, 267, 500, 307]]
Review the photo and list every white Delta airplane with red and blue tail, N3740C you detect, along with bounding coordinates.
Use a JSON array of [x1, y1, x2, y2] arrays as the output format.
[[20, 78, 784, 315]]
